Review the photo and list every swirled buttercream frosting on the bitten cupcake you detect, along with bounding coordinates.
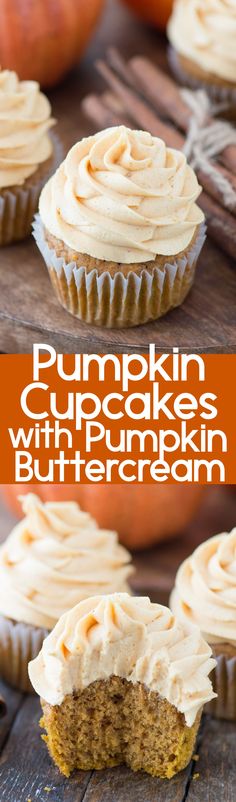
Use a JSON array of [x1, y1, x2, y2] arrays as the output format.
[[29, 593, 215, 726]]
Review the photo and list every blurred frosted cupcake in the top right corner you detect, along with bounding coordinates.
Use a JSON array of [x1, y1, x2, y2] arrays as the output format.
[[167, 0, 236, 105]]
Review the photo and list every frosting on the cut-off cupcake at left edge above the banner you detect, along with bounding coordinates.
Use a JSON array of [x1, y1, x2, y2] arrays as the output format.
[[0, 70, 54, 189]]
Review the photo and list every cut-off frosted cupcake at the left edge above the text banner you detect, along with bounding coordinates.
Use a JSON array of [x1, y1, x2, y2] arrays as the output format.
[[0, 70, 62, 245]]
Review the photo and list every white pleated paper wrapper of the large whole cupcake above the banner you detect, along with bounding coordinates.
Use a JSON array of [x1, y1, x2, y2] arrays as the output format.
[[33, 215, 206, 328]]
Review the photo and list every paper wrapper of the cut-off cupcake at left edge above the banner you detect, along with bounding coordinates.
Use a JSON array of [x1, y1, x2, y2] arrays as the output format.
[[0, 133, 63, 245]]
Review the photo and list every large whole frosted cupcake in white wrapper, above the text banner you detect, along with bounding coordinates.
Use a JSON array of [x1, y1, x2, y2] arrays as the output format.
[[34, 126, 205, 327]]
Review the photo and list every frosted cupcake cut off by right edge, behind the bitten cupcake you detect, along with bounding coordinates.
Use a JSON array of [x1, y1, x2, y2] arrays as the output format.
[[170, 529, 236, 720]]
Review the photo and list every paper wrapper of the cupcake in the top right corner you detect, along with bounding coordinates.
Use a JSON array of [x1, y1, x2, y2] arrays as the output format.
[[168, 47, 236, 107]]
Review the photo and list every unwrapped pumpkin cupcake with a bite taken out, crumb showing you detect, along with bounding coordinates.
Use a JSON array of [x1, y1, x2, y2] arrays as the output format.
[[29, 593, 215, 778]]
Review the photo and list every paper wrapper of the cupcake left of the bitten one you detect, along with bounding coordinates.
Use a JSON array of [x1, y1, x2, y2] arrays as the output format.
[[0, 615, 48, 693]]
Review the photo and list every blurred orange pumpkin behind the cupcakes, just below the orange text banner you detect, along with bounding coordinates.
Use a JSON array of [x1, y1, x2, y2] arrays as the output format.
[[1, 484, 203, 549]]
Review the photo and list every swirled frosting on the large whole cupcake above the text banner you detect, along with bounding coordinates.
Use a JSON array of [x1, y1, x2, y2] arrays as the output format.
[[39, 125, 204, 264]]
